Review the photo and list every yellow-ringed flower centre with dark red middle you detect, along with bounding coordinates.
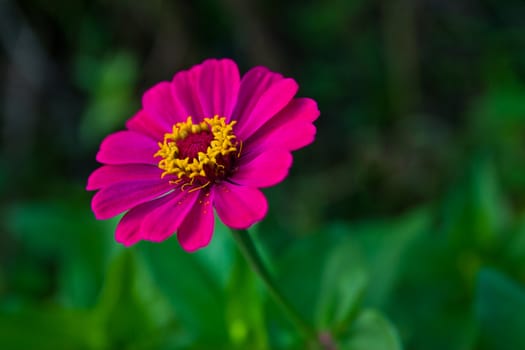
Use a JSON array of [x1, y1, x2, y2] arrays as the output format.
[[154, 115, 241, 187]]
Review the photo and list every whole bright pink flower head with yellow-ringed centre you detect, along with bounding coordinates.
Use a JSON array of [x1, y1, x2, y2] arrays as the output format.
[[87, 59, 319, 251]]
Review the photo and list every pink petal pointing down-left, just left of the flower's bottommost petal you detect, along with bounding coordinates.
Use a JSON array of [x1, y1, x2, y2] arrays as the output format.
[[142, 189, 199, 242]]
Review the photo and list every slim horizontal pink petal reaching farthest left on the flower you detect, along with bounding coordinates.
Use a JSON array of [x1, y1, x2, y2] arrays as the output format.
[[86, 164, 162, 191]]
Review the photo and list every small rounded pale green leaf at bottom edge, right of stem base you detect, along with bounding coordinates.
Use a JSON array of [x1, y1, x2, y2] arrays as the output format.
[[341, 310, 402, 350]]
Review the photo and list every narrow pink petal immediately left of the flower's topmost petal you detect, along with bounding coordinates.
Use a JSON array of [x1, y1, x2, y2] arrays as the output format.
[[171, 65, 206, 123]]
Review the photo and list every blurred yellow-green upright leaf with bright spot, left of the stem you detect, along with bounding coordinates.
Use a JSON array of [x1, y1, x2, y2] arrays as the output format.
[[226, 252, 268, 350]]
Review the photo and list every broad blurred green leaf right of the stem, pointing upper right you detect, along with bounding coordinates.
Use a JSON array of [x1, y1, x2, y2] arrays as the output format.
[[278, 209, 430, 346]]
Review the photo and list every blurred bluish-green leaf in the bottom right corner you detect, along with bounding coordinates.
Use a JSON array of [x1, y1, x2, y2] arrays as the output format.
[[475, 269, 525, 350]]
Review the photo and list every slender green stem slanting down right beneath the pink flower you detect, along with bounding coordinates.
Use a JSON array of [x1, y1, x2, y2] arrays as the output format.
[[231, 229, 318, 342]]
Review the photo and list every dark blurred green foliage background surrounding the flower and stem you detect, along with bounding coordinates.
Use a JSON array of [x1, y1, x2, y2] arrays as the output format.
[[0, 0, 525, 350]]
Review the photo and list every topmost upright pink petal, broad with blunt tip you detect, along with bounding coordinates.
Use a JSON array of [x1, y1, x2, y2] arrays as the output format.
[[199, 59, 240, 117]]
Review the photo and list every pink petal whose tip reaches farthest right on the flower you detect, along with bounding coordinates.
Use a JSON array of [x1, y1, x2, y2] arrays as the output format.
[[245, 98, 319, 151]]
